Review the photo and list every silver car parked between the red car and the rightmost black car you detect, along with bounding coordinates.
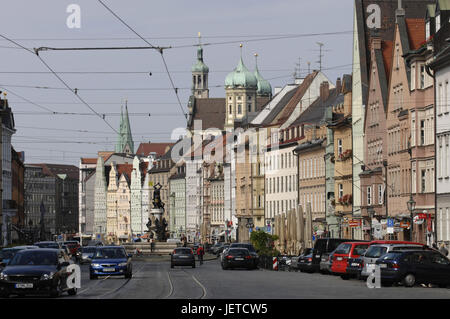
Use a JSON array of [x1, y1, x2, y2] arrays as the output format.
[[361, 243, 425, 279]]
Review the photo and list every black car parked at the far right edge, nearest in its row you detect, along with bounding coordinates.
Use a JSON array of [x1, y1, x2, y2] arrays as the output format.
[[376, 250, 450, 287]]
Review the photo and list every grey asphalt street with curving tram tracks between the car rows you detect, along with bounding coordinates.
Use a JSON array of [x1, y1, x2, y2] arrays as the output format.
[[56, 260, 450, 299]]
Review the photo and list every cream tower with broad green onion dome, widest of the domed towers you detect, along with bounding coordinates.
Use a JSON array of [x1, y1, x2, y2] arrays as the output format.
[[224, 44, 258, 130]]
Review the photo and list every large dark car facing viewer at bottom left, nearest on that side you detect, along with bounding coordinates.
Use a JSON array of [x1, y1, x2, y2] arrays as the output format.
[[0, 248, 77, 298]]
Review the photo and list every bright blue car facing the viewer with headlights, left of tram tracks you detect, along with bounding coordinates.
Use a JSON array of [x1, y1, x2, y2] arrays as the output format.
[[89, 246, 133, 279]]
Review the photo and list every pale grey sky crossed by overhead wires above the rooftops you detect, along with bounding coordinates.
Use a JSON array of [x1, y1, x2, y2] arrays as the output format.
[[0, 0, 353, 166]]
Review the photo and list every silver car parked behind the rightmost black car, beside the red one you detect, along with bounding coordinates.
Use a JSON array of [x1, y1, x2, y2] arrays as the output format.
[[353, 240, 427, 279]]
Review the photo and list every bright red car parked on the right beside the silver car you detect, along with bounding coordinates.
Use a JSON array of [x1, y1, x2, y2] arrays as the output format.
[[331, 241, 370, 279]]
